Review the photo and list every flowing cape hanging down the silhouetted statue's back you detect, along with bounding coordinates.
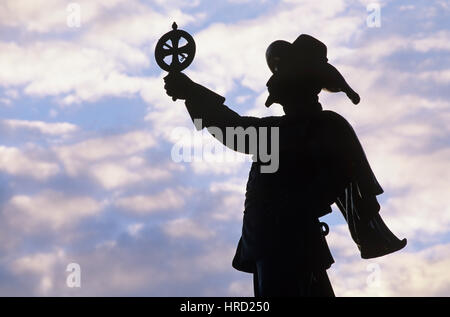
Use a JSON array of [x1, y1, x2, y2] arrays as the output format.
[[323, 111, 407, 259]]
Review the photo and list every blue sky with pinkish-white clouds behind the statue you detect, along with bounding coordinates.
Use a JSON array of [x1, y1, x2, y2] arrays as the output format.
[[0, 0, 450, 296]]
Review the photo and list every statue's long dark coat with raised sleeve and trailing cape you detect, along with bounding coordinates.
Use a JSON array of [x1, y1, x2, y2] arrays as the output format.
[[181, 85, 406, 273]]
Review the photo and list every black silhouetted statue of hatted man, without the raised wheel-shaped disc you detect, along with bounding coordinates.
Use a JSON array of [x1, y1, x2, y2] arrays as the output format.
[[159, 29, 406, 296]]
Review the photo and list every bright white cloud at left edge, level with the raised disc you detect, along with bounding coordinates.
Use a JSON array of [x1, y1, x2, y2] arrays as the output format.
[[0, 41, 144, 104]]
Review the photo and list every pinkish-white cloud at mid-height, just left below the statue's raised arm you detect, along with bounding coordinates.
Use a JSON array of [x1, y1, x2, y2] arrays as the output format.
[[53, 131, 184, 189]]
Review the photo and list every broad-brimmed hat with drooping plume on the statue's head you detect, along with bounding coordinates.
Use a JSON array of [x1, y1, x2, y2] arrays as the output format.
[[266, 34, 360, 105]]
